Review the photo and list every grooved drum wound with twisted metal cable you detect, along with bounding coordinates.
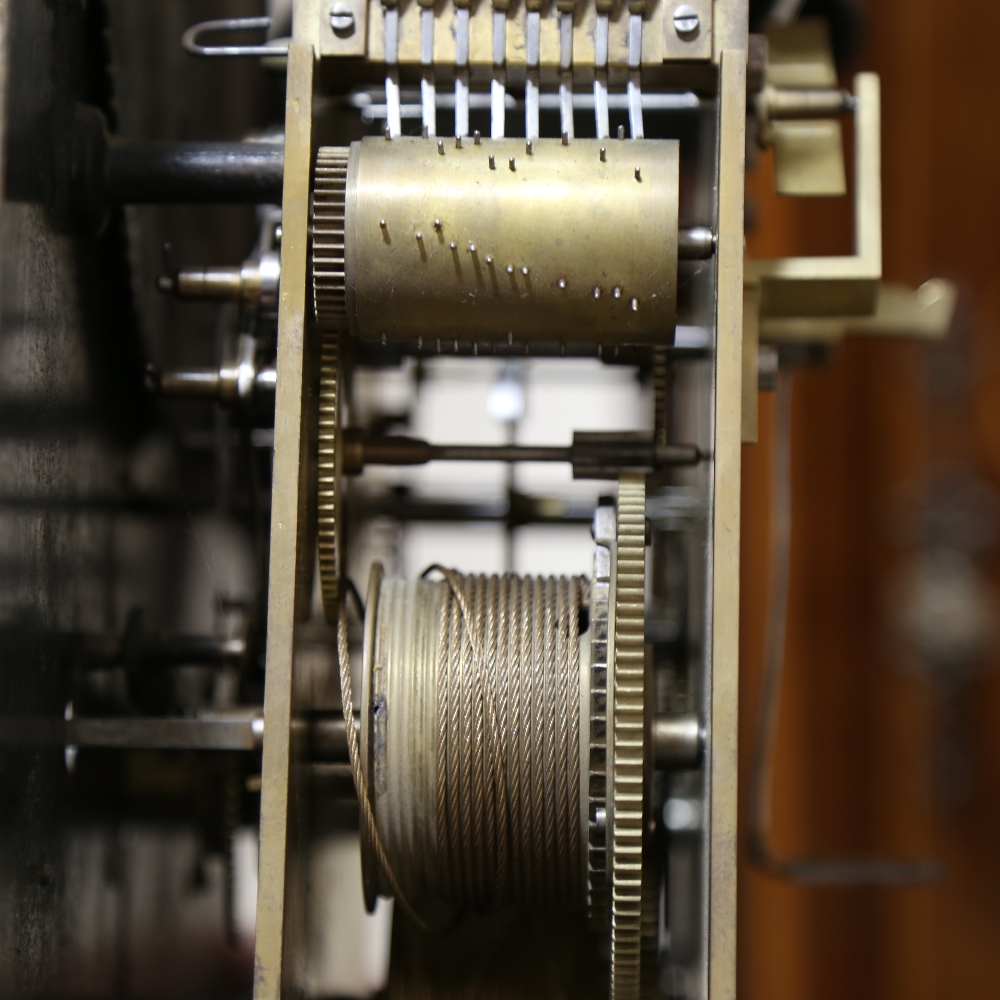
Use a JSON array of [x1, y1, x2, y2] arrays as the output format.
[[361, 566, 590, 923]]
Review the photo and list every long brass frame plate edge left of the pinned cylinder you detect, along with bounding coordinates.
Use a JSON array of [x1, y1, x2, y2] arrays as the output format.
[[254, 42, 314, 1000]]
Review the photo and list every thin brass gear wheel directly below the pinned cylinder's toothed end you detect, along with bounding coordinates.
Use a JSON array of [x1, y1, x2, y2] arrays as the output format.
[[316, 331, 340, 624]]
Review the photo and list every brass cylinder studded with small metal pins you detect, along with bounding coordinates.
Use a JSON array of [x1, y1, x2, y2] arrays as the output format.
[[320, 138, 678, 344]]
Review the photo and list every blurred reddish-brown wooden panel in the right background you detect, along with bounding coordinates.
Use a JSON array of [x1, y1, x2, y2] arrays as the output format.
[[739, 0, 1000, 1000]]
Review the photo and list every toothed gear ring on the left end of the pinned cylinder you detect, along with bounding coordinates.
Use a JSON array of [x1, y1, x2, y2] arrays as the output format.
[[312, 146, 350, 329]]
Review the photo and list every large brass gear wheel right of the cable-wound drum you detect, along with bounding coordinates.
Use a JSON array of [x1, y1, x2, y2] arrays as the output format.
[[608, 472, 646, 1000]]
